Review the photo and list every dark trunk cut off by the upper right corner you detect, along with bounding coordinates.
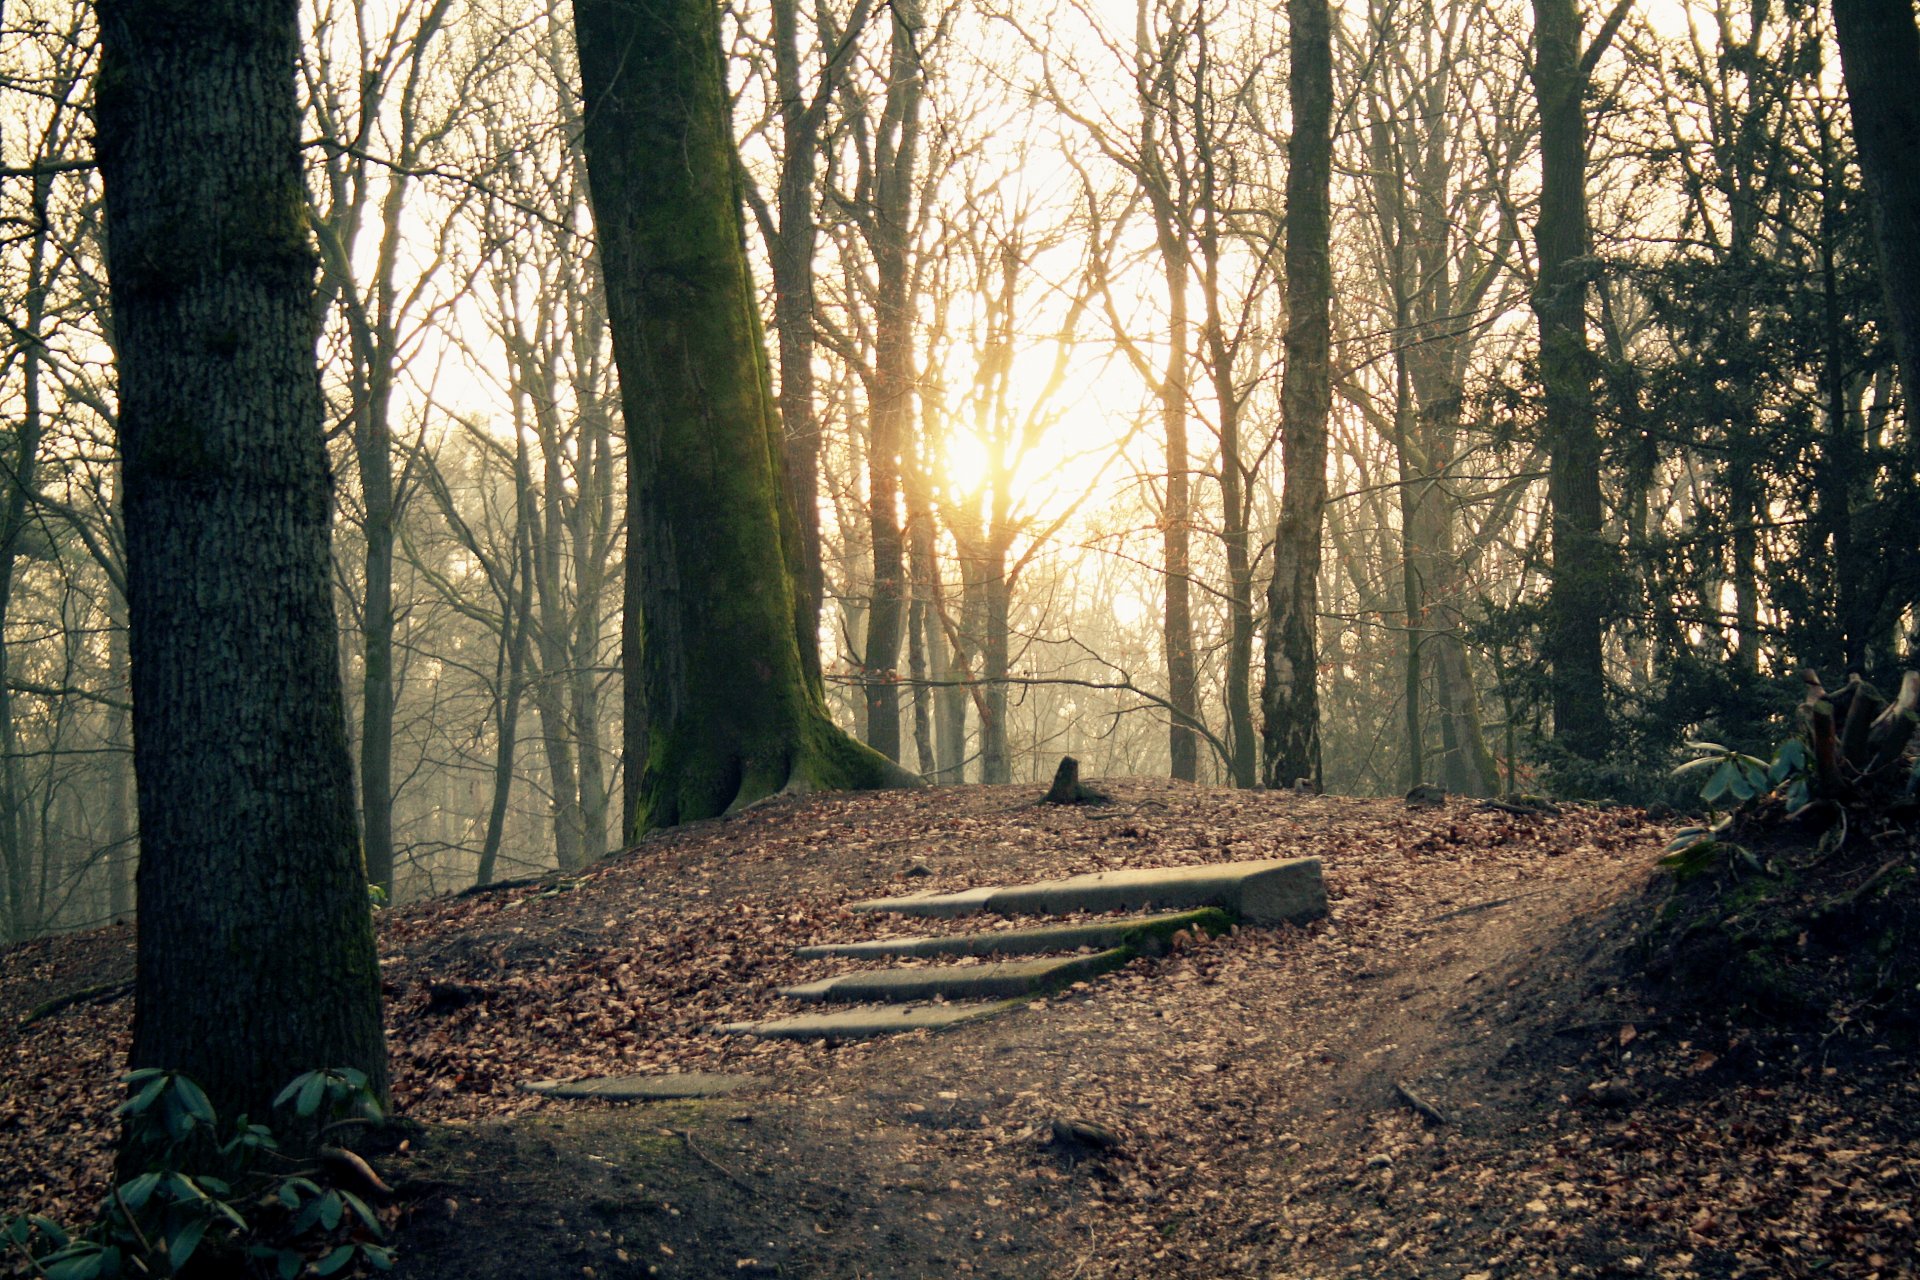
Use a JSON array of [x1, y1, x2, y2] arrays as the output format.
[[1834, 0, 1920, 422]]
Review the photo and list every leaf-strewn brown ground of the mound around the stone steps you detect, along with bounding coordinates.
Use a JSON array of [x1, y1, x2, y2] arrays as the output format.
[[0, 779, 1920, 1280]]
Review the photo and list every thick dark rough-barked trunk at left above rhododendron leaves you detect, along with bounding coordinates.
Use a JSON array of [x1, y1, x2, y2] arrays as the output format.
[[96, 0, 386, 1143]]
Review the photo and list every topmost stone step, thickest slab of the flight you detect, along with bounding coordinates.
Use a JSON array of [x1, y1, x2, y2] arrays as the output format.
[[849, 858, 1327, 925]]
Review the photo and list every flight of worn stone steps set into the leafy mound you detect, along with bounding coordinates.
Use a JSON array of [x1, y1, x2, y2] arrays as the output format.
[[720, 858, 1327, 1040]]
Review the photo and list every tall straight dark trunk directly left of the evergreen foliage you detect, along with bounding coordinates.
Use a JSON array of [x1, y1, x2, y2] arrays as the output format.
[[1532, 0, 1609, 758]]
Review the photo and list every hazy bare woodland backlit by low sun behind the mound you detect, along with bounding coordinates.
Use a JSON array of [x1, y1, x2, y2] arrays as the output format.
[[0, 0, 1920, 938]]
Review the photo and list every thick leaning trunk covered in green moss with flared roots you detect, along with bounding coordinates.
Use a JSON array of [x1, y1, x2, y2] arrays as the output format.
[[574, 0, 916, 839]]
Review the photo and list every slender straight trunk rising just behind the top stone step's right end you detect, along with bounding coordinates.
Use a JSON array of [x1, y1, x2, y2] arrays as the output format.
[[1260, 0, 1332, 791]]
